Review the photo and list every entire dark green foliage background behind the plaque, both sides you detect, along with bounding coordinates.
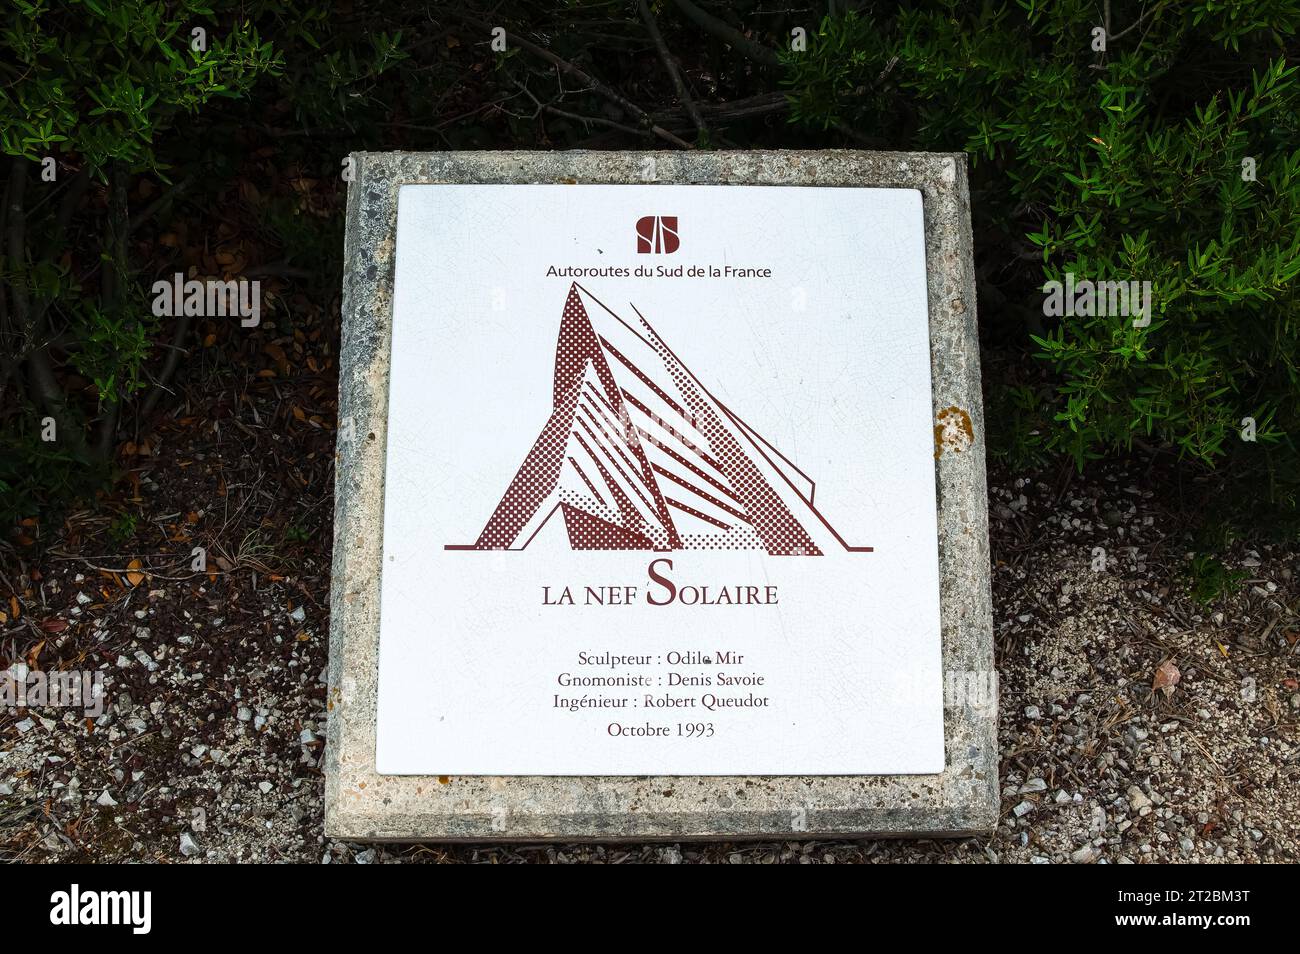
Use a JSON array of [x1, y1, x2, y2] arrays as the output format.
[[0, 0, 1300, 546]]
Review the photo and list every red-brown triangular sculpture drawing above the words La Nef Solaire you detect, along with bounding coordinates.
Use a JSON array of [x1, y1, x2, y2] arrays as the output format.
[[447, 283, 871, 556]]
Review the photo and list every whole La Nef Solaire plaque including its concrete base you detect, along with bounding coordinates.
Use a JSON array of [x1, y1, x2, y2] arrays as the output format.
[[326, 152, 997, 840]]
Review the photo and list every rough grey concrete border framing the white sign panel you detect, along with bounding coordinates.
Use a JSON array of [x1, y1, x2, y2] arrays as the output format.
[[325, 151, 998, 841]]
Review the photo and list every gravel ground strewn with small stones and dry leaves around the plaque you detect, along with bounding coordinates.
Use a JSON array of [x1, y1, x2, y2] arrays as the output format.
[[0, 452, 1300, 863]]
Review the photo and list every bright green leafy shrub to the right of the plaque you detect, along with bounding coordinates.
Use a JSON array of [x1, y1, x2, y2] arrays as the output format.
[[783, 0, 1300, 519]]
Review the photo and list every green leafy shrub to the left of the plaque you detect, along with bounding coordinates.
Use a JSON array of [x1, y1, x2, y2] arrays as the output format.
[[0, 0, 281, 493]]
